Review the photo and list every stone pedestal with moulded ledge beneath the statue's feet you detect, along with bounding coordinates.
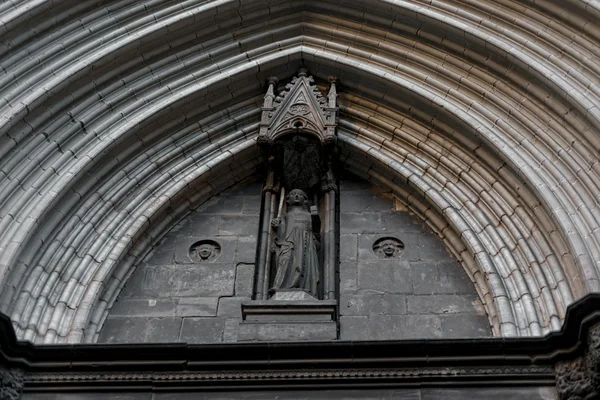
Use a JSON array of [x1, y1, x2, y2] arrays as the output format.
[[238, 290, 337, 342]]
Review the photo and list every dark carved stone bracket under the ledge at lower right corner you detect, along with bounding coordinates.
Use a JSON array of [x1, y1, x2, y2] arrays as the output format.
[[555, 324, 600, 400]]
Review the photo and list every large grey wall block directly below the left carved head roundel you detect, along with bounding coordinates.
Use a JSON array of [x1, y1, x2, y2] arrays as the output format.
[[172, 264, 235, 297]]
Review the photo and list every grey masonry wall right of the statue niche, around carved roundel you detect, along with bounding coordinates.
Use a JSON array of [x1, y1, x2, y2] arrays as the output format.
[[340, 177, 491, 340]]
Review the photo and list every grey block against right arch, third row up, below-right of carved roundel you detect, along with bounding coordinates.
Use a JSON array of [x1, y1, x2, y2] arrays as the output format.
[[411, 262, 475, 294]]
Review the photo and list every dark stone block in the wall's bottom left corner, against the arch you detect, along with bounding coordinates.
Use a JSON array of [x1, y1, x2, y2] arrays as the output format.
[[98, 317, 181, 343]]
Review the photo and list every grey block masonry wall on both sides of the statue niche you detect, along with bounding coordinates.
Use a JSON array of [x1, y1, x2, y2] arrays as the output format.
[[98, 178, 491, 343]]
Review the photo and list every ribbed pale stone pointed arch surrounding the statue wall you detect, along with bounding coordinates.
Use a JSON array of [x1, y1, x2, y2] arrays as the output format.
[[0, 0, 600, 343]]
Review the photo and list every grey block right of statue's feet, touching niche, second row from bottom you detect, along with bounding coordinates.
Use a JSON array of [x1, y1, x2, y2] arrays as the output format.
[[340, 293, 406, 316]]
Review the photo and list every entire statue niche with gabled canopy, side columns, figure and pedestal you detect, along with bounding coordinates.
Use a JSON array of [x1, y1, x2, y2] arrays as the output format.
[[240, 69, 338, 340]]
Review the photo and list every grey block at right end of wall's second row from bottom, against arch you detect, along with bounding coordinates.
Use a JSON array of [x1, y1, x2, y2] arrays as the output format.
[[407, 294, 485, 315]]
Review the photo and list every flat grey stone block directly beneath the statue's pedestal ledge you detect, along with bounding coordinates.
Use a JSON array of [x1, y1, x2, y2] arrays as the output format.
[[238, 321, 337, 342]]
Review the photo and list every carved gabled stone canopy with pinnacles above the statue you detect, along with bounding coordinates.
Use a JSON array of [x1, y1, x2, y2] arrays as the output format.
[[258, 69, 338, 144]]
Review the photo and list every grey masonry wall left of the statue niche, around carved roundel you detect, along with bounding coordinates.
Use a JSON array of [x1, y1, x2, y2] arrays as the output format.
[[98, 182, 261, 343]]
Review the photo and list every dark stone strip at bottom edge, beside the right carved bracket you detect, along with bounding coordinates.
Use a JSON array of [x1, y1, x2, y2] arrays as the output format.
[[421, 386, 558, 400]]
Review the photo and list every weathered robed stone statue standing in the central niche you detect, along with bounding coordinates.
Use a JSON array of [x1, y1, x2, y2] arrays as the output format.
[[269, 189, 320, 298]]
